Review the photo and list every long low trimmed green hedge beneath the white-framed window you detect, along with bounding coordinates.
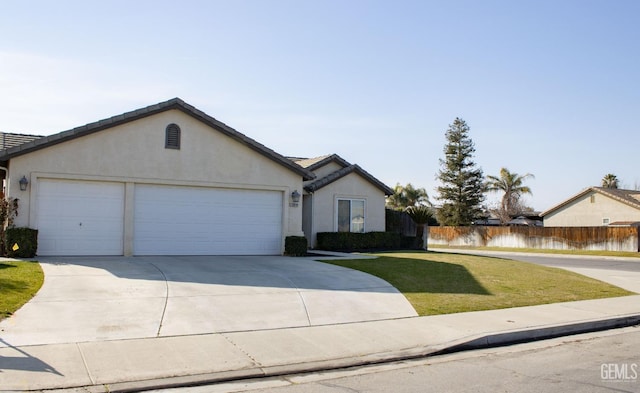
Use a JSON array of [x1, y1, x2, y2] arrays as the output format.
[[317, 232, 419, 251]]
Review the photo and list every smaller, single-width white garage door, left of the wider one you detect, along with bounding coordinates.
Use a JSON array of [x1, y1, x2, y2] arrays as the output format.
[[36, 180, 124, 255]]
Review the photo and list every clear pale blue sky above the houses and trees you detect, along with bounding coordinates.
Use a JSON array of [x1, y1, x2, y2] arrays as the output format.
[[0, 0, 640, 210]]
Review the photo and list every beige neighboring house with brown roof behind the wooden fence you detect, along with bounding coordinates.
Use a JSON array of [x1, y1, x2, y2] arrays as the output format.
[[540, 187, 640, 227]]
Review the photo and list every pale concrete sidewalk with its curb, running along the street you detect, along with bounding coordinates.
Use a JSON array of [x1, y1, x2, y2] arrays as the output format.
[[0, 295, 640, 392]]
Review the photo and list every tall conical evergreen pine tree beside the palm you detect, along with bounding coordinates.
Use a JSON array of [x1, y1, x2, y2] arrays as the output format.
[[437, 117, 485, 226]]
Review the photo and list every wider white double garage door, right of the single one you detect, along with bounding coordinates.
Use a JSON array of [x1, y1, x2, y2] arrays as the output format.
[[133, 185, 282, 255]]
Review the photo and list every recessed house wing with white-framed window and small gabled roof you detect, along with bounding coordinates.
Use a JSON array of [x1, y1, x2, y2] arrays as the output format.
[[292, 154, 393, 248]]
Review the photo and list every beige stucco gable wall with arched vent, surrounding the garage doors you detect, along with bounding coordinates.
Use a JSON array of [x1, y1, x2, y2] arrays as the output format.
[[7, 110, 302, 253]]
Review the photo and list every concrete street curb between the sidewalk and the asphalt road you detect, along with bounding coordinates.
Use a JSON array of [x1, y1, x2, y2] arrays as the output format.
[[38, 313, 640, 393]]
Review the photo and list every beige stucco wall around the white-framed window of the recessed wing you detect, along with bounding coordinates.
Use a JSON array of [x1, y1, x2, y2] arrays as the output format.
[[306, 173, 385, 247]]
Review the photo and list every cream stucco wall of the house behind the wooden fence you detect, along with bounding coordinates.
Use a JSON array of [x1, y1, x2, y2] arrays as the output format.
[[544, 192, 640, 227]]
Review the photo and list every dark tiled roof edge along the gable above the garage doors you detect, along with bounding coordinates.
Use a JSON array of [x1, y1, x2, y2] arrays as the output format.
[[0, 98, 315, 180]]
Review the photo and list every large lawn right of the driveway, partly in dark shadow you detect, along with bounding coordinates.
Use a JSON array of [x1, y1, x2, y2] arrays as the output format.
[[323, 252, 633, 315]]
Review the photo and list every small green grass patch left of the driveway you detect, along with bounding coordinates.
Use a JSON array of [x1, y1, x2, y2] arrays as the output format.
[[0, 261, 44, 320]]
